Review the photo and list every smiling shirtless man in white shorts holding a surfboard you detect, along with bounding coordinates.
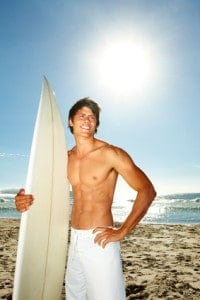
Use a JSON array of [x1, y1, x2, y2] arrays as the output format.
[[16, 98, 156, 300]]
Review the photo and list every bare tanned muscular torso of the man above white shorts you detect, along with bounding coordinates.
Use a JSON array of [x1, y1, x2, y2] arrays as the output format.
[[68, 141, 117, 229]]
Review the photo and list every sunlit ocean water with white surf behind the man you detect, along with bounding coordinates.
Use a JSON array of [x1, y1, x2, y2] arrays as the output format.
[[0, 189, 200, 224]]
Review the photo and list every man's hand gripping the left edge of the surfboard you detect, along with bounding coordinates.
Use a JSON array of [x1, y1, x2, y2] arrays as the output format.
[[15, 189, 33, 212]]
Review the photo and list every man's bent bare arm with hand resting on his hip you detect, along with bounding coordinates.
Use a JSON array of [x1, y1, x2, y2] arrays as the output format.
[[94, 148, 156, 247]]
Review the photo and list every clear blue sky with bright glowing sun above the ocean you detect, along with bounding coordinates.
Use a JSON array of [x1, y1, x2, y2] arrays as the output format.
[[0, 0, 200, 195]]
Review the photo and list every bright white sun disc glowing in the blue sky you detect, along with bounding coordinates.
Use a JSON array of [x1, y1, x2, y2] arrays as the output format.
[[94, 40, 153, 94]]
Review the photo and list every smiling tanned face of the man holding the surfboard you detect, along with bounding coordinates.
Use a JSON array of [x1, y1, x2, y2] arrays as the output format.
[[69, 106, 97, 136]]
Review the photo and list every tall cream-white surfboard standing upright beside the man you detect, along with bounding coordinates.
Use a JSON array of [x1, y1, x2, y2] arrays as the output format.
[[13, 78, 69, 300]]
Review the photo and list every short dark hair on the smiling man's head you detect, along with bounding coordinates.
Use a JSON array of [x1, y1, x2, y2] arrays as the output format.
[[68, 97, 101, 133]]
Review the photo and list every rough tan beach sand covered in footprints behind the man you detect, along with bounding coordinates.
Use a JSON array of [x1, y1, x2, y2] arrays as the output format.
[[0, 219, 200, 300]]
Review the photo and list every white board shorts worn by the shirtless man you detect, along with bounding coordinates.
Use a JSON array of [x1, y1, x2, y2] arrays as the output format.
[[65, 228, 126, 300]]
